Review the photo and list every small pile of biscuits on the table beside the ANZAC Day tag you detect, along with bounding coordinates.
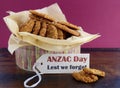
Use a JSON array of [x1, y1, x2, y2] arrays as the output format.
[[72, 68, 105, 83]]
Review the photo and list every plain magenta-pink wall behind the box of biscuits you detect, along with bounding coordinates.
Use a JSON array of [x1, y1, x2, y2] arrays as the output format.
[[0, 0, 120, 48]]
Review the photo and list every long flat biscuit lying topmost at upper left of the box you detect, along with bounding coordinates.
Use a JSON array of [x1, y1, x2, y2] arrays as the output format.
[[29, 10, 55, 21]]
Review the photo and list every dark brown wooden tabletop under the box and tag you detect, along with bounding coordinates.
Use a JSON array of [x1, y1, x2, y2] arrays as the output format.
[[0, 48, 120, 88]]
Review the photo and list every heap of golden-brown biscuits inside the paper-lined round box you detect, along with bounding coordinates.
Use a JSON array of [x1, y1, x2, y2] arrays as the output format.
[[19, 10, 80, 39]]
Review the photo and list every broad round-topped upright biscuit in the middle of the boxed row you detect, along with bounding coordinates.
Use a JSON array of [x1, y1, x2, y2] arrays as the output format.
[[46, 24, 58, 39]]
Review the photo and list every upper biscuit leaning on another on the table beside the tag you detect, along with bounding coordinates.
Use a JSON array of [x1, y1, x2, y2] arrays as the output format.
[[83, 68, 105, 77]]
